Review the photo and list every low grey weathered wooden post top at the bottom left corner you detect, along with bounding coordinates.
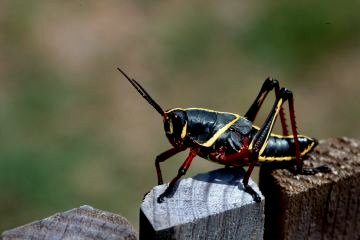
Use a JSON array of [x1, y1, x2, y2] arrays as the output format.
[[2, 206, 136, 240]]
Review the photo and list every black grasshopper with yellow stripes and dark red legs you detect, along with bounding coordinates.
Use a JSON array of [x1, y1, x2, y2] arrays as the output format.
[[118, 68, 330, 203]]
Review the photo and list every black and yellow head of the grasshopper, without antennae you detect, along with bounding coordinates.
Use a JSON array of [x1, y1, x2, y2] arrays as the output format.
[[163, 109, 188, 146]]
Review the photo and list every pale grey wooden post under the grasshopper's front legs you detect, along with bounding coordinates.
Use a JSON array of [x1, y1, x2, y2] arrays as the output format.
[[140, 168, 264, 240]]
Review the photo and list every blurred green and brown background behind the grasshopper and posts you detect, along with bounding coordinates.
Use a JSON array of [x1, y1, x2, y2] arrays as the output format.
[[0, 0, 360, 232]]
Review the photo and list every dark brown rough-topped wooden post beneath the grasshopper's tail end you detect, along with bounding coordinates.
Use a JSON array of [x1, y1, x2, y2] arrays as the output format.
[[260, 138, 360, 239]]
